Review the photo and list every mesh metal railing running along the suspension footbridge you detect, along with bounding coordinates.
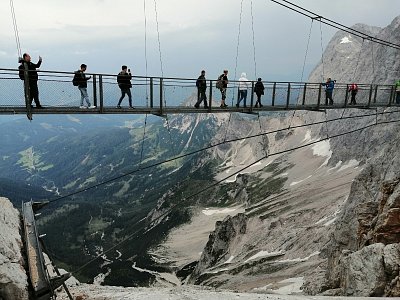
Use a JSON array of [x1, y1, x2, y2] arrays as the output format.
[[0, 69, 397, 114]]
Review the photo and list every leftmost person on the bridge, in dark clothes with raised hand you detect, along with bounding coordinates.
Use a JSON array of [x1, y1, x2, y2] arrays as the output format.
[[18, 53, 43, 108]]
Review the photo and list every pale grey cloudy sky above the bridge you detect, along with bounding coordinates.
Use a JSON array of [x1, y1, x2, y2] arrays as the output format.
[[0, 0, 400, 81]]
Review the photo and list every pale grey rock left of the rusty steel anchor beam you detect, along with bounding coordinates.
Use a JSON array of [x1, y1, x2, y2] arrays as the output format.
[[0, 197, 28, 300]]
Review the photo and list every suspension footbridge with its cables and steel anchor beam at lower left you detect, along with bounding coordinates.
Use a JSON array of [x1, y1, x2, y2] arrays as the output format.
[[4, 0, 400, 299]]
